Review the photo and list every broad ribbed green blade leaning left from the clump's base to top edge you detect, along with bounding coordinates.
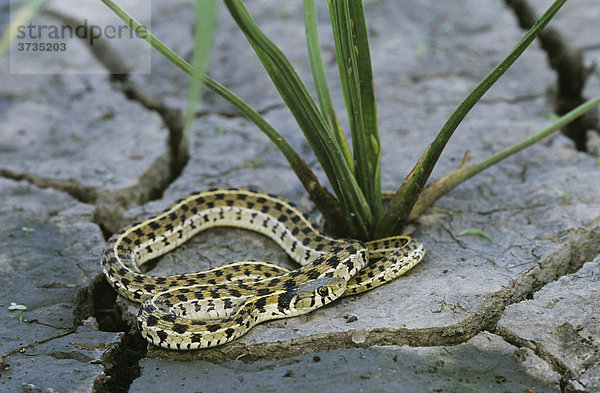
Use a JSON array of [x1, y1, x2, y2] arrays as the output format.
[[225, 0, 374, 239]]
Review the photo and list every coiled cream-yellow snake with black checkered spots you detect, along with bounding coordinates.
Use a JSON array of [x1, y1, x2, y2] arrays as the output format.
[[101, 188, 425, 350]]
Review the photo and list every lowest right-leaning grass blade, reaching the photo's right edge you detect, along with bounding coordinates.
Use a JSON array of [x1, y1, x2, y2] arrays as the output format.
[[409, 96, 600, 220]]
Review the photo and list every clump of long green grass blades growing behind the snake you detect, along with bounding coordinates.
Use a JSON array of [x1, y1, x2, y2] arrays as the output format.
[[96, 0, 600, 240]]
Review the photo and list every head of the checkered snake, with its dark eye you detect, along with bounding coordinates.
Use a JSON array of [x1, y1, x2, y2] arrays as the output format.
[[292, 277, 346, 313]]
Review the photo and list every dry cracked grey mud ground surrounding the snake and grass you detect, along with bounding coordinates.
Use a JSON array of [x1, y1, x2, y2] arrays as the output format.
[[0, 0, 600, 393]]
